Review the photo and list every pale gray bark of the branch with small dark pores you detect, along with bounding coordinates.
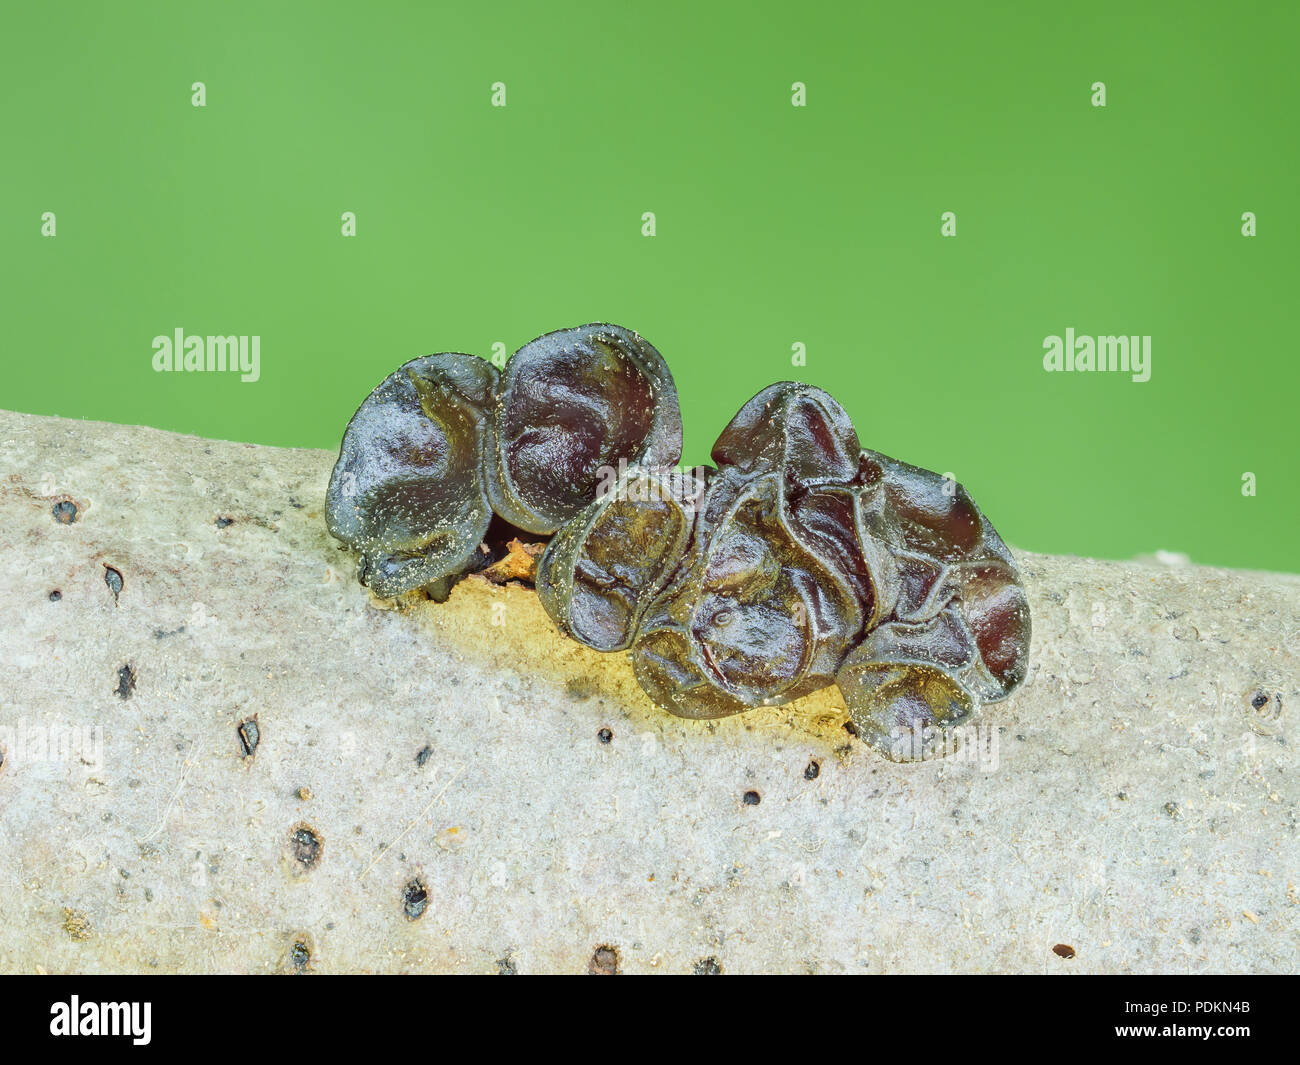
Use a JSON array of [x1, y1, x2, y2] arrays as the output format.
[[0, 414, 1300, 973]]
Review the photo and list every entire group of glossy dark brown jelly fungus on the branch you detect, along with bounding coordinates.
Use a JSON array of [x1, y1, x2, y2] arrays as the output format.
[[328, 325, 1030, 759]]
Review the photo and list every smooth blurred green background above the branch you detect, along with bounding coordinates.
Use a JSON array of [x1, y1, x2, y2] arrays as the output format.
[[0, 3, 1300, 571]]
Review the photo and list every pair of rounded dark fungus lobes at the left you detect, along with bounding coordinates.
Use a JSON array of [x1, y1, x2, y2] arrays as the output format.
[[326, 324, 681, 598]]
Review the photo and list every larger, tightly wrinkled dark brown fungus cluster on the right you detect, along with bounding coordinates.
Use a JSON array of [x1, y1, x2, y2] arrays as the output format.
[[537, 382, 1030, 759]]
